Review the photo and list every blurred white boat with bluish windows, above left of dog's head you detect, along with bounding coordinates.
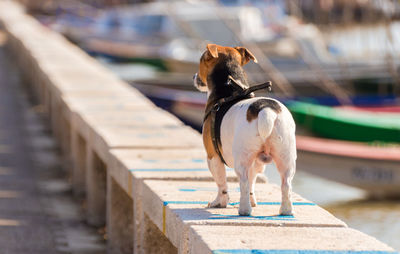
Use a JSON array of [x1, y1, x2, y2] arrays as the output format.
[[51, 2, 267, 70]]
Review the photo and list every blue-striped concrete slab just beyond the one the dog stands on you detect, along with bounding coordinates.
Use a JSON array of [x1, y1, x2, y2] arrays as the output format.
[[107, 148, 242, 195]]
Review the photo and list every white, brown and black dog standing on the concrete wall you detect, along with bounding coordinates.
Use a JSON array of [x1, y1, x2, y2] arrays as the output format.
[[194, 44, 297, 216]]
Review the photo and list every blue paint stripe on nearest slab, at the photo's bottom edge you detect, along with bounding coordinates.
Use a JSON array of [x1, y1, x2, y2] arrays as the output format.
[[212, 249, 399, 254]]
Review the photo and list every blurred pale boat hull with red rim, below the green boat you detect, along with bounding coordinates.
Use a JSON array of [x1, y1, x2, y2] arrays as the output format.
[[296, 135, 400, 198]]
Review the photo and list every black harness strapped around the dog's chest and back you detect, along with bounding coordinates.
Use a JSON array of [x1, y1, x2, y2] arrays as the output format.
[[203, 76, 272, 164]]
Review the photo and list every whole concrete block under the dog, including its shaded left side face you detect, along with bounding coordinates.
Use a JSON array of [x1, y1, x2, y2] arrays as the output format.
[[140, 180, 346, 251]]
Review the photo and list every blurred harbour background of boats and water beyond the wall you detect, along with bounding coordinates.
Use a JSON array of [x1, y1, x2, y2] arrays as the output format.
[[17, 0, 400, 250]]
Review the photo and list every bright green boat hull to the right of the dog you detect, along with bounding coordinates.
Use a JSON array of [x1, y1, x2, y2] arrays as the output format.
[[288, 102, 400, 143]]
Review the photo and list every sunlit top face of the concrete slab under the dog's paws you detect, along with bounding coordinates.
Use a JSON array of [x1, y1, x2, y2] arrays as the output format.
[[143, 180, 346, 227]]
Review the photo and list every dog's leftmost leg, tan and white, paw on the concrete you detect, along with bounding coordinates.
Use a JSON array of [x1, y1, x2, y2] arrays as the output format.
[[207, 157, 229, 208]]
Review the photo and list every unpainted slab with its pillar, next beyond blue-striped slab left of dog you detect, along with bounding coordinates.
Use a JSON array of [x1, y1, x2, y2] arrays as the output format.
[[86, 125, 201, 225]]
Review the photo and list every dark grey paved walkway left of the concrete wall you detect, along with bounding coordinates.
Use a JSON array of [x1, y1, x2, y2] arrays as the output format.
[[0, 34, 105, 254]]
